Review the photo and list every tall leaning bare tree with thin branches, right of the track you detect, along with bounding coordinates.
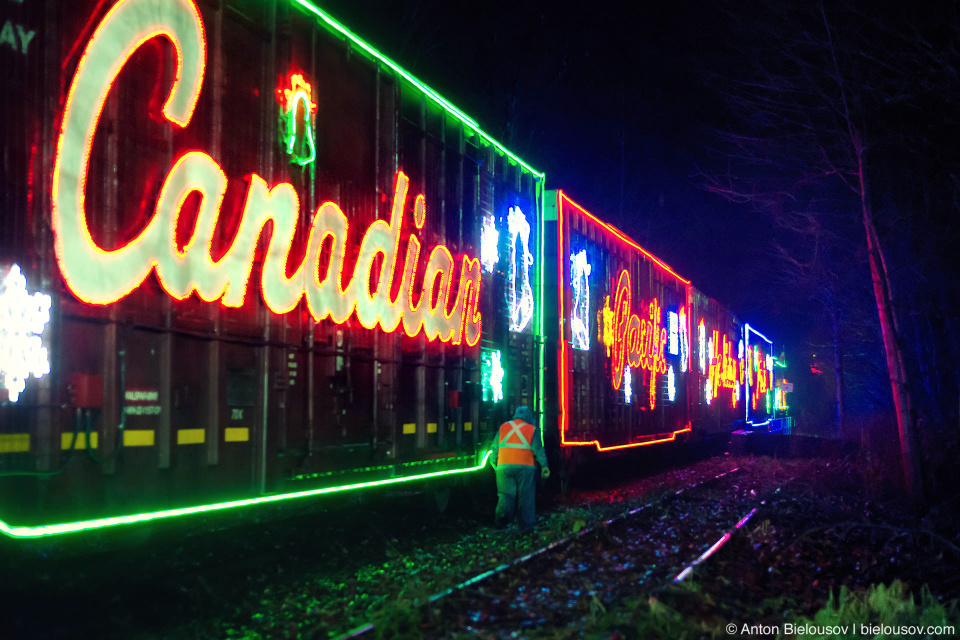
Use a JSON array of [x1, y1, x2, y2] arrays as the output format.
[[703, 0, 955, 501]]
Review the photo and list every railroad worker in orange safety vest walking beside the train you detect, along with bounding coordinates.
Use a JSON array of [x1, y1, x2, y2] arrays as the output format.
[[491, 406, 550, 532]]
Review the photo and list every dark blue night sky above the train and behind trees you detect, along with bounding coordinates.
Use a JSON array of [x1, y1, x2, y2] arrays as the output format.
[[290, 0, 960, 424]]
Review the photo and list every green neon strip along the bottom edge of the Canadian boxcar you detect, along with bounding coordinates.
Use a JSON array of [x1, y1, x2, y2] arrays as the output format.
[[0, 451, 491, 538]]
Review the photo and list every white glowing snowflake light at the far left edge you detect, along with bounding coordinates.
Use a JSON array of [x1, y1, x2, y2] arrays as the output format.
[[0, 264, 50, 402]]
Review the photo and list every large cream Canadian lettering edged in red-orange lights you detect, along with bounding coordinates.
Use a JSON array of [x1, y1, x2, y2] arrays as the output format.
[[52, 0, 482, 346]]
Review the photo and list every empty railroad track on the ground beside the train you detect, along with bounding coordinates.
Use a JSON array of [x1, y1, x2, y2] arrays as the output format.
[[340, 462, 779, 640]]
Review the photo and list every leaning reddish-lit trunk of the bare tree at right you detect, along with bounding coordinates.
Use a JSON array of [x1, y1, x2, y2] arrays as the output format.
[[858, 158, 923, 505]]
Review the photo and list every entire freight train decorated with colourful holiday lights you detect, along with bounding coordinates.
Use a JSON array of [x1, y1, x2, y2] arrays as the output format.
[[0, 0, 783, 538]]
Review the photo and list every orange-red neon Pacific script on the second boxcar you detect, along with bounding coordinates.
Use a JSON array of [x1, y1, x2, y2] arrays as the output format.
[[604, 269, 667, 392]]
